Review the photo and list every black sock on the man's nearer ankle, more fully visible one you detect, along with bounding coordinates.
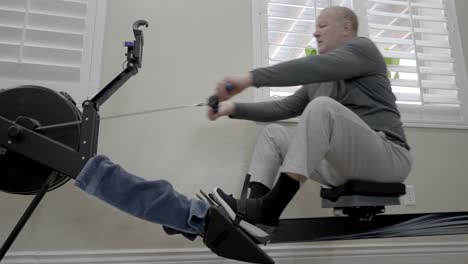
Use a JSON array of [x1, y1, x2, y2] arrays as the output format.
[[261, 173, 300, 219]]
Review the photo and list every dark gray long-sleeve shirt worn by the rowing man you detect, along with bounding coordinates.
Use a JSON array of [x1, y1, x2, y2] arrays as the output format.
[[231, 37, 409, 149]]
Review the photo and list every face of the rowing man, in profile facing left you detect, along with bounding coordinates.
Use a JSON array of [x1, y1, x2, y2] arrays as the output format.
[[314, 10, 349, 54]]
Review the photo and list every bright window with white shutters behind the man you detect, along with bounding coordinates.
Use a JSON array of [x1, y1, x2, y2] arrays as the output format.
[[253, 0, 468, 127]]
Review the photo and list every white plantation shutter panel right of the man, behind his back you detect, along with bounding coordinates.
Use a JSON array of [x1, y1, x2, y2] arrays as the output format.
[[367, 0, 467, 125]]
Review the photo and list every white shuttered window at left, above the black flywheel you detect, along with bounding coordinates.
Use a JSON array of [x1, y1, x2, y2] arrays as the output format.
[[0, 0, 105, 105]]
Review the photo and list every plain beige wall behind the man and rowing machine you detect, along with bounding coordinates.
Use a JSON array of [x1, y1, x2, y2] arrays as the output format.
[[0, 0, 468, 255]]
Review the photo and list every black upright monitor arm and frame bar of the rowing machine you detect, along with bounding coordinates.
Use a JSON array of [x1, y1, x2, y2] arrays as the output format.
[[0, 20, 148, 182]]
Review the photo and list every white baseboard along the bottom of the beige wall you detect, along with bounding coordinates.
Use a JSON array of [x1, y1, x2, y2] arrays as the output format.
[[2, 242, 468, 264]]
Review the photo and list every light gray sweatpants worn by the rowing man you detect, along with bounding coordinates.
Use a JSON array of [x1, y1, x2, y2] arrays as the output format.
[[249, 97, 412, 188]]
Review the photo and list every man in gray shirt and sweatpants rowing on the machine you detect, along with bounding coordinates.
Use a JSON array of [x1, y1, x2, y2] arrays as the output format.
[[208, 7, 412, 236]]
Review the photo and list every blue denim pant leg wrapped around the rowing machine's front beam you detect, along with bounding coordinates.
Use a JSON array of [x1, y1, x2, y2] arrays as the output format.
[[75, 155, 209, 234]]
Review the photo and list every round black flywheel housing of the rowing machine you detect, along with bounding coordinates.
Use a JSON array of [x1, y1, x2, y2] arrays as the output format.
[[0, 86, 81, 195]]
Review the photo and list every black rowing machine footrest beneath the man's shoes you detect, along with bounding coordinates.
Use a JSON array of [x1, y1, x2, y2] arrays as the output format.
[[203, 206, 275, 264]]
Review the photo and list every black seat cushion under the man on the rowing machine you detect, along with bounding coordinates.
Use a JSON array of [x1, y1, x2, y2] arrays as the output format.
[[320, 181, 406, 201]]
